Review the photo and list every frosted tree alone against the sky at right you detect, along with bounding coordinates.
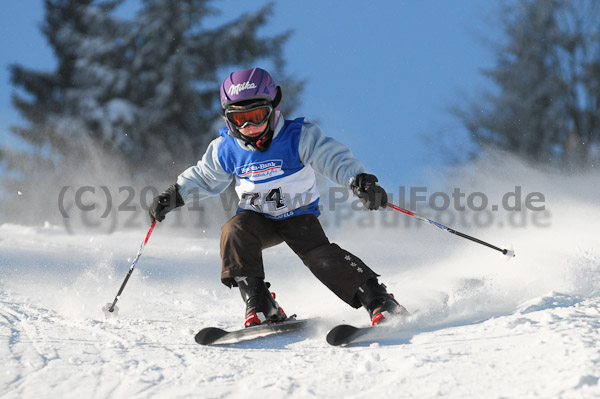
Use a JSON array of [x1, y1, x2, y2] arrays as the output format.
[[457, 0, 600, 168]]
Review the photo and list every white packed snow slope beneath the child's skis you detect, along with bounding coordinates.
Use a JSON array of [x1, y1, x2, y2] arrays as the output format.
[[0, 157, 600, 399]]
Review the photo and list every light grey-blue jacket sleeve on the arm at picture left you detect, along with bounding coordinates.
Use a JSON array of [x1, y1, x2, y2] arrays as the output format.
[[177, 137, 233, 203]]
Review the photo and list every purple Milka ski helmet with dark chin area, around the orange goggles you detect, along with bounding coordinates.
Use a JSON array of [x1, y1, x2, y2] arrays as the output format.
[[220, 68, 281, 151]]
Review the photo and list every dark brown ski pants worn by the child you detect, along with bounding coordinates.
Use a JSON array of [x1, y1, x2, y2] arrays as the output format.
[[221, 211, 378, 308]]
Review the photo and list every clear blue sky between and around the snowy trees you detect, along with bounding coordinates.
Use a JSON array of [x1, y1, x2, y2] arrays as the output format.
[[0, 0, 498, 191]]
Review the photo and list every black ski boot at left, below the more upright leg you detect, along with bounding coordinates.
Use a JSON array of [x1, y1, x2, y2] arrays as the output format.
[[235, 277, 287, 327]]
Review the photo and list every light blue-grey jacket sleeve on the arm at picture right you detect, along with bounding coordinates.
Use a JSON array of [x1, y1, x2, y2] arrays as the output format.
[[298, 123, 366, 187]]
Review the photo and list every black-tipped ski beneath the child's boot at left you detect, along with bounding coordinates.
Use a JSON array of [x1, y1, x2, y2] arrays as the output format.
[[194, 316, 308, 345]]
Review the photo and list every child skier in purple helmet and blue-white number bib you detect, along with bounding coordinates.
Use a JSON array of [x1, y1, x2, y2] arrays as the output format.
[[149, 68, 407, 327]]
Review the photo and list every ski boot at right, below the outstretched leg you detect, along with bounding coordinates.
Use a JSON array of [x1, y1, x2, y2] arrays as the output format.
[[356, 278, 409, 325]]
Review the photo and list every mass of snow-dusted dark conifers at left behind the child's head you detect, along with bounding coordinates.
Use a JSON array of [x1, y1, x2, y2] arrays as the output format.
[[0, 0, 302, 225]]
